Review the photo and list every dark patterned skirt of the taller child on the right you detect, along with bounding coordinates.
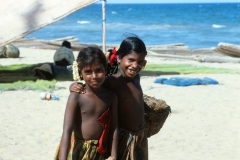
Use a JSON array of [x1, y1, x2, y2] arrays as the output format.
[[118, 128, 148, 160]]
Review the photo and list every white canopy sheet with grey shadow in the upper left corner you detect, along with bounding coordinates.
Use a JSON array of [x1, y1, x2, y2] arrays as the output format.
[[0, 0, 99, 47]]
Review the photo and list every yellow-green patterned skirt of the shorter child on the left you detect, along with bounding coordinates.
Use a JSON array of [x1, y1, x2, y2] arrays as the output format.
[[54, 133, 104, 160]]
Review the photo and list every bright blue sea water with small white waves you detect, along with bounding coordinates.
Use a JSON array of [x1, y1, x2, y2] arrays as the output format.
[[26, 3, 240, 49]]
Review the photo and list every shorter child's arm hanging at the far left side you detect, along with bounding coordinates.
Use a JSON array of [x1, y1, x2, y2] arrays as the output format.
[[59, 92, 78, 160]]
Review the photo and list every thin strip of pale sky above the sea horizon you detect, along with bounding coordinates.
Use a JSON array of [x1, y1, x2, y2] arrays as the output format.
[[106, 0, 240, 3]]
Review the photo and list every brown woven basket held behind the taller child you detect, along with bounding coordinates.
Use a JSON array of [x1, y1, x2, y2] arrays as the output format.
[[143, 95, 171, 137]]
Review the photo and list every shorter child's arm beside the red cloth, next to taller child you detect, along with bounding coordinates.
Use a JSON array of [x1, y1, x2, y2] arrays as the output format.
[[110, 94, 118, 160]]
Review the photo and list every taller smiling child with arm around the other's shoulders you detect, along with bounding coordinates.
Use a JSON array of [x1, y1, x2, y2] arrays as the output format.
[[67, 37, 148, 160]]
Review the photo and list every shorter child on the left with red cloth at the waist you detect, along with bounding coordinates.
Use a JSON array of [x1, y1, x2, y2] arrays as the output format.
[[55, 47, 118, 160]]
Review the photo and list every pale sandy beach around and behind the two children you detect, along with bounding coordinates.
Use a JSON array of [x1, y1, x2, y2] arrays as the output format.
[[0, 48, 240, 160]]
